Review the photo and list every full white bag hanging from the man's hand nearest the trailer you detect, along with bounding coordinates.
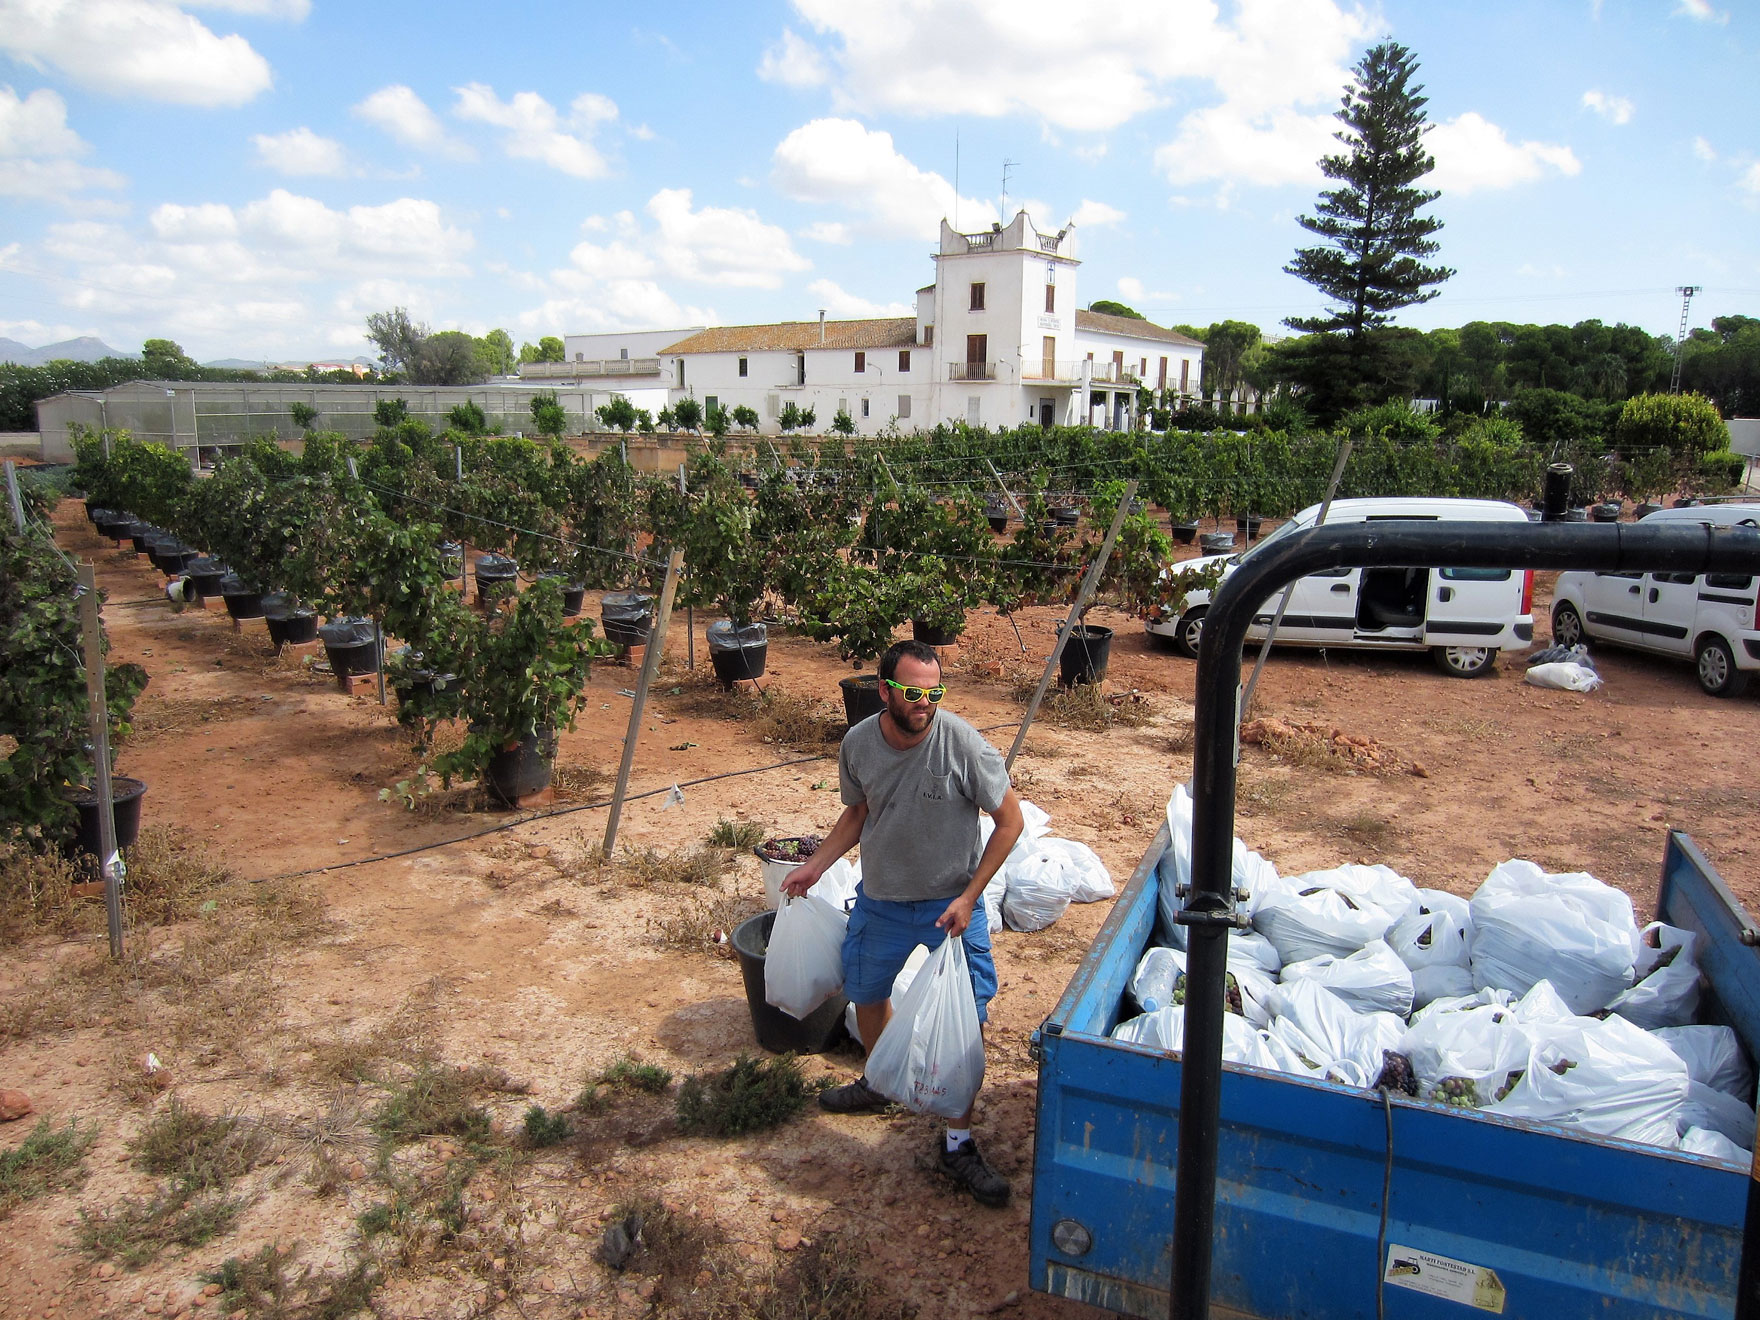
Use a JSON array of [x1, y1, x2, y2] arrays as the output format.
[[864, 936, 984, 1118]]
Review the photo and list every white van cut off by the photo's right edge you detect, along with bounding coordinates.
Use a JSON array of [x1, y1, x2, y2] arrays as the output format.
[[1552, 503, 1760, 697]]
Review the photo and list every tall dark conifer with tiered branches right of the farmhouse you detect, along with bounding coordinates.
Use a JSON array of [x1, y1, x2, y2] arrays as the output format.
[[1283, 42, 1454, 414]]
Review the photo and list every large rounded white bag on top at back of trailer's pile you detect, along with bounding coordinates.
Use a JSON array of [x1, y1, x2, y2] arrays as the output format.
[[1471, 861, 1639, 1014]]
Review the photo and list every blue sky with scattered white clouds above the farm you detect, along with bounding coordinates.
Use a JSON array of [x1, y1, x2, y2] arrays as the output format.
[[0, 0, 1760, 359]]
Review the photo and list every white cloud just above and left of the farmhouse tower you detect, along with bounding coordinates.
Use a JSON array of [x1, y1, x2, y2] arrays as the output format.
[[771, 120, 998, 239]]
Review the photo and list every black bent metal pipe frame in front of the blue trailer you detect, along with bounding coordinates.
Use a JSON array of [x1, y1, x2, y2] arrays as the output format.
[[1169, 521, 1760, 1320]]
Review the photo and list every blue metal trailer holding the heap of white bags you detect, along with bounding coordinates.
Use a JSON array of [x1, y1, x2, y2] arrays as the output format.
[[1030, 825, 1760, 1320]]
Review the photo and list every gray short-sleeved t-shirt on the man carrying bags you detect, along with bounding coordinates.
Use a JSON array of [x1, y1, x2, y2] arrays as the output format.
[[838, 711, 1008, 903]]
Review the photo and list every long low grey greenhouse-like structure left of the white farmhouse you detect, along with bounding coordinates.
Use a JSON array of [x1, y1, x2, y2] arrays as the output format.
[[37, 380, 611, 463]]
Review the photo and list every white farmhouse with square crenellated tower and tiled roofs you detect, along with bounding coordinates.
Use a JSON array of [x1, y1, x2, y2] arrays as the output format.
[[591, 211, 1204, 435]]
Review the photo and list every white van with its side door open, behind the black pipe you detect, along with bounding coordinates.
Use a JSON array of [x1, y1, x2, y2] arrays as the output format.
[[1146, 496, 1535, 678]]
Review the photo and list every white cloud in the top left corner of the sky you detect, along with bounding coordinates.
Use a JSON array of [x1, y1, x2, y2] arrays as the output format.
[[0, 0, 273, 107]]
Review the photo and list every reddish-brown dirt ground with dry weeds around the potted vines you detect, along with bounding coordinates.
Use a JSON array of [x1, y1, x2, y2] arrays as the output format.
[[0, 502, 1760, 1320]]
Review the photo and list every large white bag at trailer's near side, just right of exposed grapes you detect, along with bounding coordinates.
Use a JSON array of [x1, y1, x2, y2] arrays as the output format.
[[1487, 1017, 1690, 1148]]
